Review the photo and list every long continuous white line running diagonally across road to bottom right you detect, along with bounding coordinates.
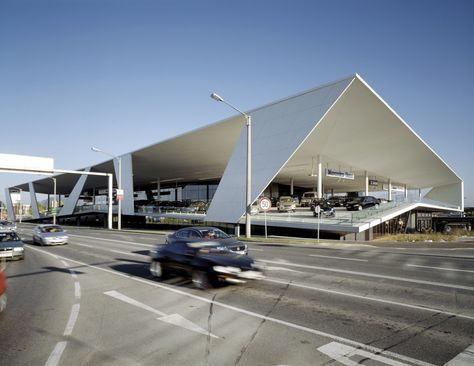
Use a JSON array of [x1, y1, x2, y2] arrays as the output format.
[[28, 245, 435, 366]]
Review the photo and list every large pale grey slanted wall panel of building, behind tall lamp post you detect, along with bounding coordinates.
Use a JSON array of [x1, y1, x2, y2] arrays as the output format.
[[206, 77, 354, 223]]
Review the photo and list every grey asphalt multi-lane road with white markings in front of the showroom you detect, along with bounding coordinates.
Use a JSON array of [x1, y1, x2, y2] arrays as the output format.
[[0, 226, 474, 366]]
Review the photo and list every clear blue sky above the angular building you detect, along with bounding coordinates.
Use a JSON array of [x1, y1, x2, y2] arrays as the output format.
[[0, 0, 474, 206]]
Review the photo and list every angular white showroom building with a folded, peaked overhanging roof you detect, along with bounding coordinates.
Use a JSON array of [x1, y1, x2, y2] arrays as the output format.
[[6, 75, 464, 239]]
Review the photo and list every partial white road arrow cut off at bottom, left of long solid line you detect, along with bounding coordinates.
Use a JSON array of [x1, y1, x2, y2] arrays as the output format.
[[318, 342, 409, 366]]
